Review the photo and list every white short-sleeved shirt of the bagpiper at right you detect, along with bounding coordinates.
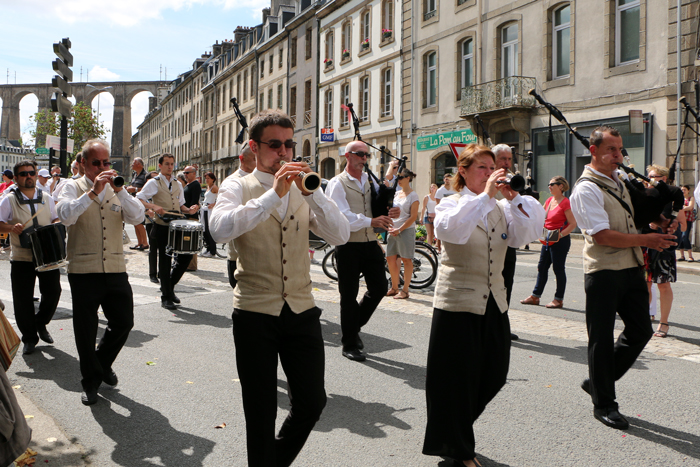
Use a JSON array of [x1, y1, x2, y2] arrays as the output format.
[[569, 165, 626, 235]]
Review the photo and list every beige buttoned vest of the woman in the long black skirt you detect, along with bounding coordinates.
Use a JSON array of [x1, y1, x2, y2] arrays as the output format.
[[433, 193, 508, 315]]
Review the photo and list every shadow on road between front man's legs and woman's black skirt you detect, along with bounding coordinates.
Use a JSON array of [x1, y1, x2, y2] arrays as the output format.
[[314, 394, 415, 438]]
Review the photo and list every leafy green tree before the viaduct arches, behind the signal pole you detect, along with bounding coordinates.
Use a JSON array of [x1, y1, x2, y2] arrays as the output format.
[[29, 102, 107, 163]]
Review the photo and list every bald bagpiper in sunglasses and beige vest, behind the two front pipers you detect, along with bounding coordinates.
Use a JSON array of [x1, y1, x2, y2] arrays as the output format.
[[326, 141, 393, 362]]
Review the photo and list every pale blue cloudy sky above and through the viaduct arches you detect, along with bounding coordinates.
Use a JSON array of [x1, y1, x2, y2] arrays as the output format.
[[0, 0, 270, 147]]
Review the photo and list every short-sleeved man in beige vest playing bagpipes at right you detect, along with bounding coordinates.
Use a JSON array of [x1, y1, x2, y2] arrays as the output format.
[[570, 126, 676, 430]]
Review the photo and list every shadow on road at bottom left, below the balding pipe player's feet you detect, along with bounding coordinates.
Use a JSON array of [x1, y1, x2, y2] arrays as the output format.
[[91, 390, 216, 467]]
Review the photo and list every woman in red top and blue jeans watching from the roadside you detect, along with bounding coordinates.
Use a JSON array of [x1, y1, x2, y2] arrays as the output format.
[[520, 175, 576, 308]]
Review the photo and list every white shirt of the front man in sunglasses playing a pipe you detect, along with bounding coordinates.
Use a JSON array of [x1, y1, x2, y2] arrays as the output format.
[[208, 169, 350, 245]]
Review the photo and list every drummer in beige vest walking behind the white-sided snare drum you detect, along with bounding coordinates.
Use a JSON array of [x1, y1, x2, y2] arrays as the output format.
[[136, 154, 199, 310]]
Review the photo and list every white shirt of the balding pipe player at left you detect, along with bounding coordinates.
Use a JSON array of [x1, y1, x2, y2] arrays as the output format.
[[56, 177, 145, 227]]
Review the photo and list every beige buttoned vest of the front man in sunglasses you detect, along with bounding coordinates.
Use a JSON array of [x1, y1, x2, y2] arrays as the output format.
[[233, 175, 315, 316]]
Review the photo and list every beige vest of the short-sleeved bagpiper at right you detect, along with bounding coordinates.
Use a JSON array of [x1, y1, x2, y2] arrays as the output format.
[[576, 166, 644, 274]]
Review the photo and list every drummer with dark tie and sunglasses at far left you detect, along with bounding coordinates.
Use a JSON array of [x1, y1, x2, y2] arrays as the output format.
[[0, 160, 61, 355]]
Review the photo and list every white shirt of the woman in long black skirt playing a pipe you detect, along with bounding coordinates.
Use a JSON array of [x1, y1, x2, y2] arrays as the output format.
[[434, 187, 545, 248]]
